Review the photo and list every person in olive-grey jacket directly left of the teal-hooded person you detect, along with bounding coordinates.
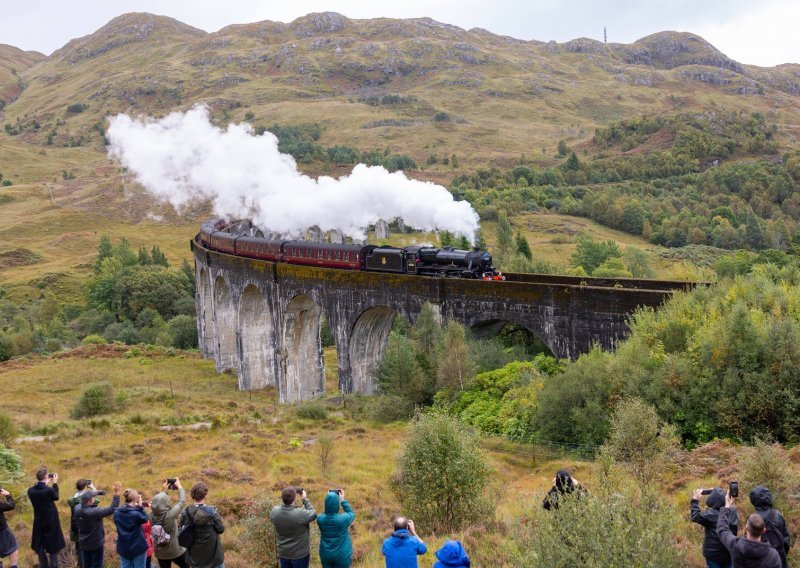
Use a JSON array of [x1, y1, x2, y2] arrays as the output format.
[[269, 487, 317, 568]]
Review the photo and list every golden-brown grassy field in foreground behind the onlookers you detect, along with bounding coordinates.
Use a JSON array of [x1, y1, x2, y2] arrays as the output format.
[[0, 345, 792, 568]]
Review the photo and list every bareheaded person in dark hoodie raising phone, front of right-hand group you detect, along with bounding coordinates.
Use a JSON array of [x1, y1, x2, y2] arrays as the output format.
[[717, 492, 781, 568]]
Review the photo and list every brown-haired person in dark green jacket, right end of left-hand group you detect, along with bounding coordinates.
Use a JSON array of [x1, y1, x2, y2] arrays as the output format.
[[181, 483, 225, 568]]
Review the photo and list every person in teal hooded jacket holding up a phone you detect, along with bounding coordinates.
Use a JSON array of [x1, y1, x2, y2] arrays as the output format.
[[317, 489, 356, 568]]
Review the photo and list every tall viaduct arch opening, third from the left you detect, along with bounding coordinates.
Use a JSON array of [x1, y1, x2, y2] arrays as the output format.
[[239, 284, 277, 390]]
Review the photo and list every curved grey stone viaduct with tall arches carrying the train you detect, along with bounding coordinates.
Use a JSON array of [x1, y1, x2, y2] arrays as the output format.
[[191, 239, 687, 402]]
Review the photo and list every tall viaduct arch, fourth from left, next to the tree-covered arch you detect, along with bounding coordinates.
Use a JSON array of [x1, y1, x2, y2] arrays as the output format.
[[278, 294, 325, 402]]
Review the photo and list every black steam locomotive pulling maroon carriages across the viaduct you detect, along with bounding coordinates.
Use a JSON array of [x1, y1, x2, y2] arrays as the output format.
[[198, 219, 505, 280]]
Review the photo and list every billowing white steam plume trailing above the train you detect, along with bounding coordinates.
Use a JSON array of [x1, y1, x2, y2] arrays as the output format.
[[108, 106, 478, 239]]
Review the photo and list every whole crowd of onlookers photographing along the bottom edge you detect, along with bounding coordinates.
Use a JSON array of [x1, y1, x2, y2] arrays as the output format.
[[0, 467, 791, 568]]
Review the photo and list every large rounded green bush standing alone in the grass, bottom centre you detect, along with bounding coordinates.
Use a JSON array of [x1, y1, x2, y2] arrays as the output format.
[[395, 413, 493, 533]]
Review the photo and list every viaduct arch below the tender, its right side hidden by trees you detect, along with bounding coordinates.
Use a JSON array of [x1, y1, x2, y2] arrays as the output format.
[[348, 306, 397, 394]]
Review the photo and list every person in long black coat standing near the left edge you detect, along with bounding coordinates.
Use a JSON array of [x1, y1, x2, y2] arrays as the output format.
[[28, 467, 67, 568]]
